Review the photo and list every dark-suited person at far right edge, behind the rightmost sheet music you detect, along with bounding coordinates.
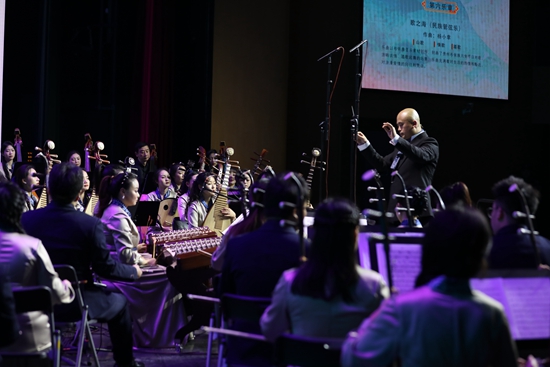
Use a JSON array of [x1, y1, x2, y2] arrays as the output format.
[[489, 176, 550, 269]]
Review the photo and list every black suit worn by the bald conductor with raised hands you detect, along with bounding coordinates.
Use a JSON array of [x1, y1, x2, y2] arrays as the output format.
[[361, 132, 439, 217]]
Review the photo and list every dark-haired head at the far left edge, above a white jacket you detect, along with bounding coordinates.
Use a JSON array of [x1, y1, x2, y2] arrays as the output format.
[[0, 182, 26, 233]]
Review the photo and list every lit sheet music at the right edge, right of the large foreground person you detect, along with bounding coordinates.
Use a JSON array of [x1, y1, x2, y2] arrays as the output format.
[[470, 277, 550, 340]]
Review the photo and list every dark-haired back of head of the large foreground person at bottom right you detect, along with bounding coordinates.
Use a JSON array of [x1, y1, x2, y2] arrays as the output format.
[[417, 205, 492, 285]]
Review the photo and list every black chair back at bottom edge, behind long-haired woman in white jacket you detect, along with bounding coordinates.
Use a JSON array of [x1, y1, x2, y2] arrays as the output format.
[[275, 334, 344, 367]]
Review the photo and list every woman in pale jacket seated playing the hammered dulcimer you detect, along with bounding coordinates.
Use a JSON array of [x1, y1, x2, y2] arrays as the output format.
[[96, 173, 156, 266]]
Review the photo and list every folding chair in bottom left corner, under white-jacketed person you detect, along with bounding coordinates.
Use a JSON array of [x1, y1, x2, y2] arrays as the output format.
[[1, 286, 61, 367]]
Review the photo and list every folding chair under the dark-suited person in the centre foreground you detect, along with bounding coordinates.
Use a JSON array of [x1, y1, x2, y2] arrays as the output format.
[[218, 293, 272, 367]]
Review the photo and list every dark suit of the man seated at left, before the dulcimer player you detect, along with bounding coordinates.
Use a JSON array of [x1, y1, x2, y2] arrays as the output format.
[[21, 202, 137, 365]]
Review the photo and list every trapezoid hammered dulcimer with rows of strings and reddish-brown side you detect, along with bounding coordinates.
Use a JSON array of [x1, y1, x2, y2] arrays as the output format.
[[149, 227, 222, 269]]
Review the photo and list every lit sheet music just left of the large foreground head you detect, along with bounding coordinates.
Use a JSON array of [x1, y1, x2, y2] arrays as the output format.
[[376, 243, 422, 293]]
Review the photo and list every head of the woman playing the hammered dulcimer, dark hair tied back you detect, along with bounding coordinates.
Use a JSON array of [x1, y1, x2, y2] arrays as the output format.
[[96, 172, 139, 218]]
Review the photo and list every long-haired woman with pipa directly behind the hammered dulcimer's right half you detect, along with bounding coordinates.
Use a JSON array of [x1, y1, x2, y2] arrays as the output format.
[[185, 172, 236, 228]]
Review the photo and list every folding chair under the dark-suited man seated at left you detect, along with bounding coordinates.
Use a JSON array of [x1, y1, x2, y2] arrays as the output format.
[[54, 265, 100, 367]]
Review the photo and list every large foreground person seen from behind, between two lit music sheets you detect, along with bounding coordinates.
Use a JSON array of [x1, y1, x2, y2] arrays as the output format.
[[342, 207, 517, 367]]
